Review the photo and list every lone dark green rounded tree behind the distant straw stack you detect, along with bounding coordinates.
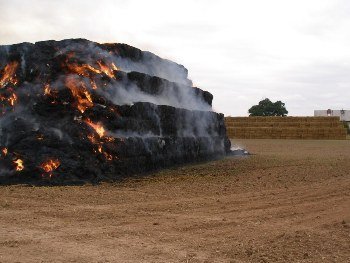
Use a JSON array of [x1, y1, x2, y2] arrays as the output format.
[[248, 98, 288, 116]]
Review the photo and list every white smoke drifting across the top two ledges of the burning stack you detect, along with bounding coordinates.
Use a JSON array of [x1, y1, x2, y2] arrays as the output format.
[[51, 40, 208, 111]]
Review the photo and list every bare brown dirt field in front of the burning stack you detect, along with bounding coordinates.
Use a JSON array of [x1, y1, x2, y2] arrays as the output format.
[[0, 140, 350, 262]]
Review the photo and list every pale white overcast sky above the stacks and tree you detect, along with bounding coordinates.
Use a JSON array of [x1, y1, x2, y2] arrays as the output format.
[[0, 0, 350, 116]]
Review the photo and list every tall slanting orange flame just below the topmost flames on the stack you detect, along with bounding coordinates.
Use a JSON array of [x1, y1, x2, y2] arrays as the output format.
[[66, 78, 94, 113]]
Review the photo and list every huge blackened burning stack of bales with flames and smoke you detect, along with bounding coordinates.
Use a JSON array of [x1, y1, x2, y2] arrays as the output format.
[[0, 39, 230, 184]]
